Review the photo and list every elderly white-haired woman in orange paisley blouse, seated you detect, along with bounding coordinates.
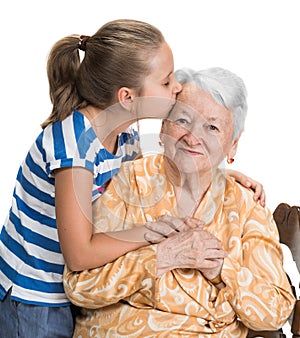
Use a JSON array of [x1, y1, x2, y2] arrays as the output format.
[[64, 68, 294, 338]]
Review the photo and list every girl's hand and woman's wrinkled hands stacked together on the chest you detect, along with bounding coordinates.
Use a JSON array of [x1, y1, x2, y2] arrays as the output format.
[[145, 216, 227, 280]]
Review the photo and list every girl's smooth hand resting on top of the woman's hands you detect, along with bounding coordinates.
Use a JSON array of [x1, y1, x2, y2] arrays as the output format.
[[144, 215, 204, 244]]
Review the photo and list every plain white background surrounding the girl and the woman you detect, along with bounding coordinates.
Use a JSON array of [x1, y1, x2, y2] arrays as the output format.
[[0, 0, 300, 332]]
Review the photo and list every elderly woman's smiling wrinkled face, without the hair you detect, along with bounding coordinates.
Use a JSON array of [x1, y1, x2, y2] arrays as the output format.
[[161, 83, 238, 173]]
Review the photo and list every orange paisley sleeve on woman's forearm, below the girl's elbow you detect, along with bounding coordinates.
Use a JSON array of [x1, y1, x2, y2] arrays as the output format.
[[63, 245, 156, 309]]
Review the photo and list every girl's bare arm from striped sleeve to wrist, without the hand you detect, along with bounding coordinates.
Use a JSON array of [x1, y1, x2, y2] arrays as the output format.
[[55, 168, 148, 271]]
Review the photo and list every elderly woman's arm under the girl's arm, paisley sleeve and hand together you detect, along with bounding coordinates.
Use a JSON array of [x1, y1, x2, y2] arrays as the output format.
[[63, 226, 226, 309]]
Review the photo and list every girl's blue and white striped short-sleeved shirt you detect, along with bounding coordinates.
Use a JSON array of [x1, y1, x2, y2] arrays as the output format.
[[0, 111, 139, 306]]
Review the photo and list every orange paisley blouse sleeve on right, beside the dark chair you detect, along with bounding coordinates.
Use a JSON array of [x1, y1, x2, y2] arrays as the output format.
[[217, 195, 295, 330]]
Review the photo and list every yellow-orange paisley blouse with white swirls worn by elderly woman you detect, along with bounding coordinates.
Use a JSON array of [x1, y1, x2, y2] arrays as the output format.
[[64, 154, 295, 338]]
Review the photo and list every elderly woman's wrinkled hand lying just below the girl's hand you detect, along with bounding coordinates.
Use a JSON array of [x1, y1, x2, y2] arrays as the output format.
[[157, 227, 227, 279]]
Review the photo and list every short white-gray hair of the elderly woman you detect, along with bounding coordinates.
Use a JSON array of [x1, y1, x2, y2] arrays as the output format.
[[175, 67, 248, 139]]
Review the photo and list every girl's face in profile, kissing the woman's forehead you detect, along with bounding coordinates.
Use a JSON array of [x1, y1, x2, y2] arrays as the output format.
[[136, 42, 182, 118]]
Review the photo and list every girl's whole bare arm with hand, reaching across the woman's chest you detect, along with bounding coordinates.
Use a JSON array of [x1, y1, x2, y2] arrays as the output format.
[[55, 167, 191, 271]]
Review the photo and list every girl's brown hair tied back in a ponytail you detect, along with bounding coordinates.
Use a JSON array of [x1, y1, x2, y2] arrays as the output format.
[[42, 19, 164, 128]]
